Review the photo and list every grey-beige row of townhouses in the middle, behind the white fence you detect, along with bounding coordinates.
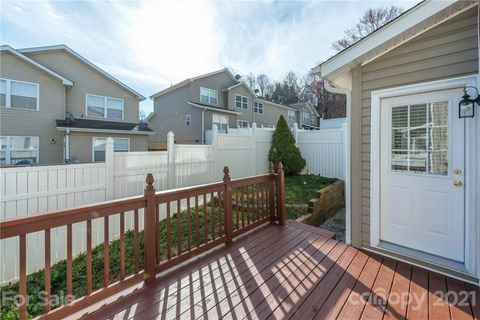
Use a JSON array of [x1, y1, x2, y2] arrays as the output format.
[[147, 68, 296, 149]]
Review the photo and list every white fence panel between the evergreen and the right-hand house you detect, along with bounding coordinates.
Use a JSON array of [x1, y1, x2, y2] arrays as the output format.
[[296, 128, 346, 179]]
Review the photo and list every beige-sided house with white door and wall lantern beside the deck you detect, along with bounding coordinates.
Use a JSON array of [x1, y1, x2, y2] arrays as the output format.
[[315, 1, 480, 284]]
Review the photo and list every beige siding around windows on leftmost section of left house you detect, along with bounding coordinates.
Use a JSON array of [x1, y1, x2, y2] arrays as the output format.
[[0, 52, 65, 164]]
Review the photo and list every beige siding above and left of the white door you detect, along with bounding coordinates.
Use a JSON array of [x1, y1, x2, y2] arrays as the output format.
[[352, 8, 478, 246]]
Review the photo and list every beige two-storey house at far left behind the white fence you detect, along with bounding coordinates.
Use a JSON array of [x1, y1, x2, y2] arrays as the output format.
[[0, 45, 153, 165]]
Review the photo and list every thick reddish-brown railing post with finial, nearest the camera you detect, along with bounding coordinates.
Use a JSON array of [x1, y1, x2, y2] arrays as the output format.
[[144, 173, 157, 283]]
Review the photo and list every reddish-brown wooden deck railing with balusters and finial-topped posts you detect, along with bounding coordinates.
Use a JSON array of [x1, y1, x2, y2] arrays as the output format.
[[0, 163, 285, 319]]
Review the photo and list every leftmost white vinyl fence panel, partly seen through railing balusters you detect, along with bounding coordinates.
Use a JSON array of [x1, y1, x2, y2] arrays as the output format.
[[0, 163, 106, 283]]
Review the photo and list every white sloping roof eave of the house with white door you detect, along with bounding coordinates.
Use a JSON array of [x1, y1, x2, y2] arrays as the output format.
[[313, 0, 478, 81]]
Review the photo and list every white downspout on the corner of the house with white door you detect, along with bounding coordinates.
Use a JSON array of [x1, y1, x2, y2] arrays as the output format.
[[324, 81, 352, 244]]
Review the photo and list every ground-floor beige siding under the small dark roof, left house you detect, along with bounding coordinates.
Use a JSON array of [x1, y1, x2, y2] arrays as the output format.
[[70, 132, 148, 163]]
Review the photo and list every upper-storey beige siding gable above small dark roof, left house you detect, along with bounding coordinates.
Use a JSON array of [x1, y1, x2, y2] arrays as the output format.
[[27, 51, 138, 122]]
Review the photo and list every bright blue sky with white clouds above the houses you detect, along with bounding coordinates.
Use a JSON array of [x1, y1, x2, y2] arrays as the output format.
[[0, 0, 418, 114]]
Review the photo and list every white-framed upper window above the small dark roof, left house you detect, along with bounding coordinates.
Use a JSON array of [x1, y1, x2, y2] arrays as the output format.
[[86, 94, 123, 119]]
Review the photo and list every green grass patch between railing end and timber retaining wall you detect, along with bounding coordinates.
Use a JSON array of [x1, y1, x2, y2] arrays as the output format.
[[285, 174, 337, 219]]
